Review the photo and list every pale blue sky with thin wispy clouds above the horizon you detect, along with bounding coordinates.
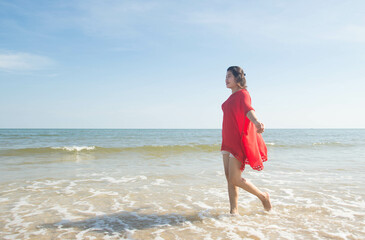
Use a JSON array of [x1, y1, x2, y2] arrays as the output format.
[[0, 0, 365, 129]]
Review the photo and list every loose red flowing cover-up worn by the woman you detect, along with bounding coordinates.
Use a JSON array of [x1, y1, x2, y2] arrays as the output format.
[[221, 89, 267, 171]]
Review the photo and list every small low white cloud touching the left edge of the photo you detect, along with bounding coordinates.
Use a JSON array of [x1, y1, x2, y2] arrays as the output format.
[[0, 52, 54, 71]]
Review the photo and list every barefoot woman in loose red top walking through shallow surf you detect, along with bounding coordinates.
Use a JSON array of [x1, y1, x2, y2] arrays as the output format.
[[221, 66, 271, 214]]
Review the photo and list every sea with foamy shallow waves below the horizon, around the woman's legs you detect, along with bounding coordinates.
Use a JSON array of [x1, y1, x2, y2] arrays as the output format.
[[0, 129, 365, 240]]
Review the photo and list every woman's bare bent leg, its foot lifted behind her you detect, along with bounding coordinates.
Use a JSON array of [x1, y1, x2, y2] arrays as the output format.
[[228, 157, 271, 211]]
